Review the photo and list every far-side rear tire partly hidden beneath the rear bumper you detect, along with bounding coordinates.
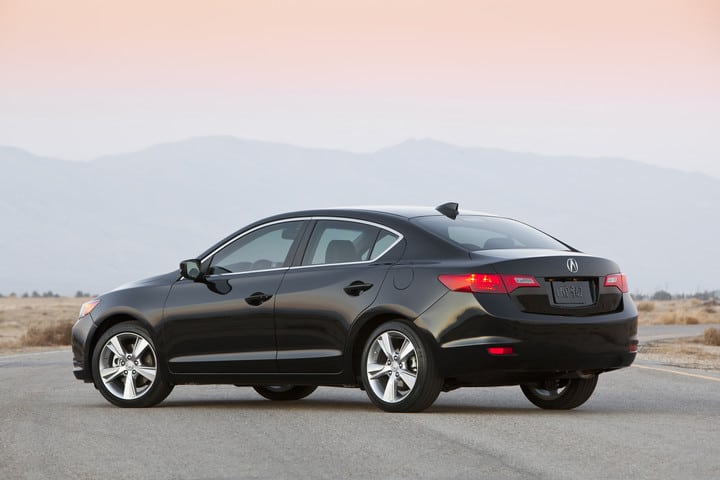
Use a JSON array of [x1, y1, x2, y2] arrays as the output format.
[[520, 375, 598, 410]]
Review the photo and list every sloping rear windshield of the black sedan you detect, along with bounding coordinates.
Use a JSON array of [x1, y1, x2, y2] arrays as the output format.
[[412, 215, 570, 251]]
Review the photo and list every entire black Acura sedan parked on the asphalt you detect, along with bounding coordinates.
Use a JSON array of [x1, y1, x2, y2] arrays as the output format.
[[72, 203, 638, 412]]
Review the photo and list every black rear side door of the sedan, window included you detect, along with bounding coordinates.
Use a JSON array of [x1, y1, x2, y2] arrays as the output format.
[[275, 219, 402, 374]]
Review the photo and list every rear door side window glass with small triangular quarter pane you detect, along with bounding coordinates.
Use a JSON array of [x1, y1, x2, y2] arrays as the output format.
[[302, 220, 397, 265]]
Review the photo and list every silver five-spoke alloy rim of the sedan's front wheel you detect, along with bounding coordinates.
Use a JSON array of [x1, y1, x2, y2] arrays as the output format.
[[98, 332, 157, 400]]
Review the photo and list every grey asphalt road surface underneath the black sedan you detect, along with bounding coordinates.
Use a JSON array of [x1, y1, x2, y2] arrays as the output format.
[[0, 351, 720, 480]]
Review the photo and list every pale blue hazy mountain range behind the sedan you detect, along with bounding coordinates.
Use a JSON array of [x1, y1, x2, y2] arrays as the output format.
[[0, 137, 720, 295]]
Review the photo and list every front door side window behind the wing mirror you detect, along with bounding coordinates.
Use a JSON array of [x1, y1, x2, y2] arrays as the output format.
[[210, 221, 303, 274]]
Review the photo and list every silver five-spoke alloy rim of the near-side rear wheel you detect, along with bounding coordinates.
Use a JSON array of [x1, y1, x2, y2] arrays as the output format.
[[366, 330, 418, 403]]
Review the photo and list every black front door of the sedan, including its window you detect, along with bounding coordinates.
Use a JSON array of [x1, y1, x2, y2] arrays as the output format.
[[161, 220, 307, 374]]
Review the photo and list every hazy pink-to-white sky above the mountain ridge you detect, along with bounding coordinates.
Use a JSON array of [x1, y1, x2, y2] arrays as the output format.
[[0, 0, 720, 177]]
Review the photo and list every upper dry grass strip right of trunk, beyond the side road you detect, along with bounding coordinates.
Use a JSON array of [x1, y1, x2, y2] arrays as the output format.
[[636, 299, 720, 325]]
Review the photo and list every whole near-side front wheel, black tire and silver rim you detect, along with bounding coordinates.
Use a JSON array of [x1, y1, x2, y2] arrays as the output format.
[[92, 322, 173, 408]]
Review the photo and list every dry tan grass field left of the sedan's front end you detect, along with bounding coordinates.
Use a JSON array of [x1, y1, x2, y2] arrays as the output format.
[[0, 297, 88, 351]]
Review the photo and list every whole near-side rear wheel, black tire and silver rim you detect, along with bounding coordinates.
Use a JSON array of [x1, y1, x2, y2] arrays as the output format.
[[360, 321, 444, 412]]
